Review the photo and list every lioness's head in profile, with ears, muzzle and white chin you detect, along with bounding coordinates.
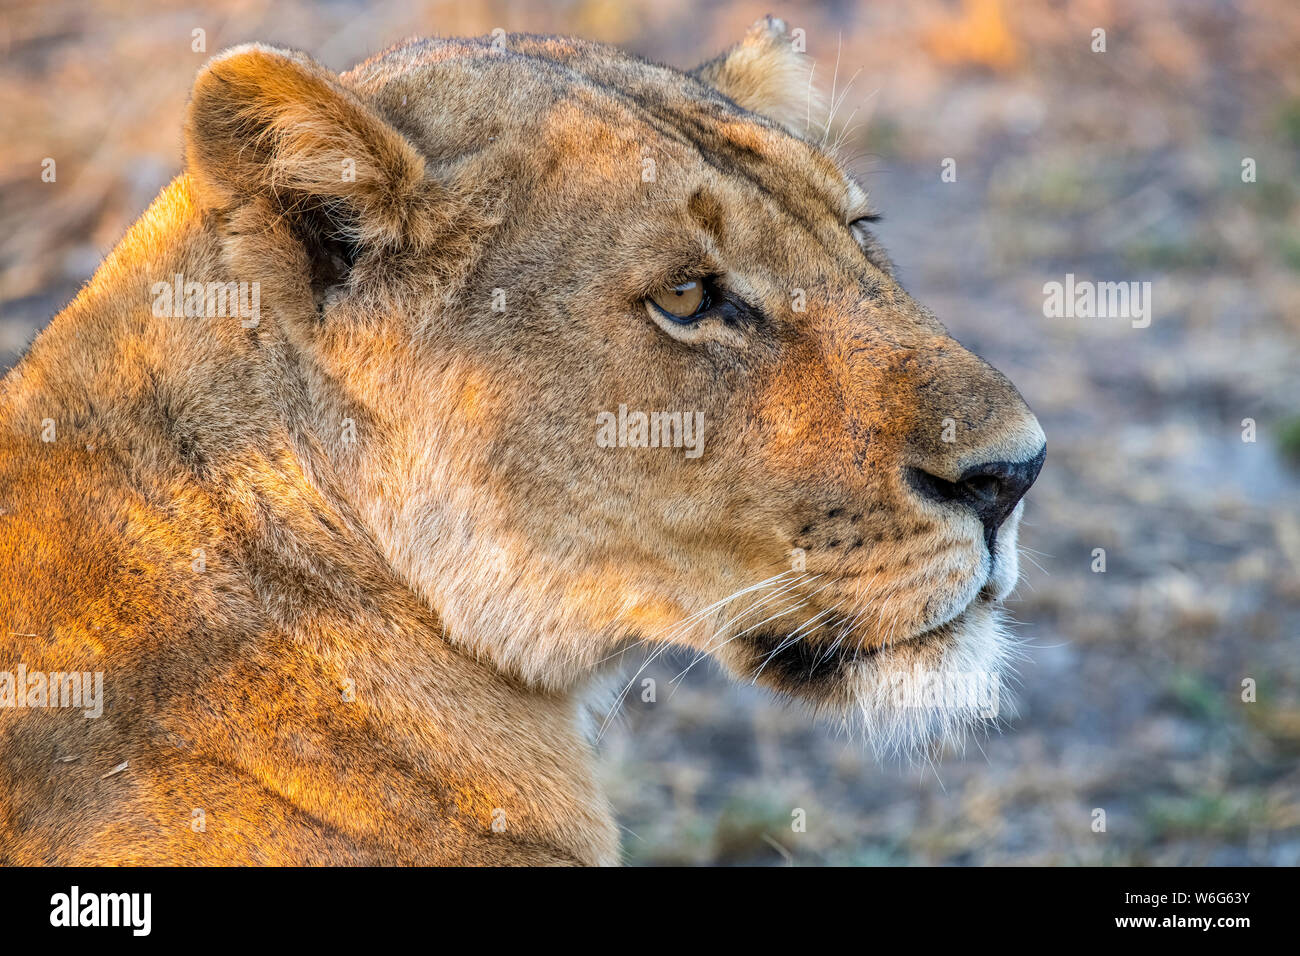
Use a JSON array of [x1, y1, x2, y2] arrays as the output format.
[[189, 21, 1045, 759]]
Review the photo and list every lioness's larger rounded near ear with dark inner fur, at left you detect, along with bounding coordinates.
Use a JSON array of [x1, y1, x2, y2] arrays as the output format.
[[185, 44, 439, 245]]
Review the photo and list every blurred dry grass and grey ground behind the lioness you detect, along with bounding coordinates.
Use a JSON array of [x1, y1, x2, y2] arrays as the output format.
[[0, 0, 1300, 865]]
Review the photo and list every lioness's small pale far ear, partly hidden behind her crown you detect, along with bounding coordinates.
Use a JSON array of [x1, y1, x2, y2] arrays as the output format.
[[692, 17, 822, 135]]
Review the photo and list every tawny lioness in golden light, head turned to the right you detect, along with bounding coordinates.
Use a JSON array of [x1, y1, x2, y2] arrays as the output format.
[[0, 20, 1045, 864]]
